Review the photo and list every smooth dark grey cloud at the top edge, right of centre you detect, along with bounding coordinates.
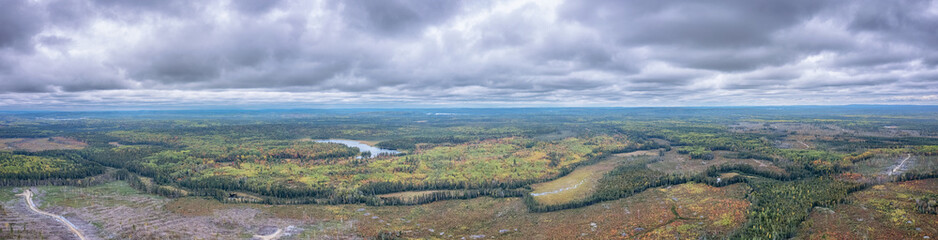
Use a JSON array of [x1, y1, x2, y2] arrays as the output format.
[[560, 0, 825, 48]]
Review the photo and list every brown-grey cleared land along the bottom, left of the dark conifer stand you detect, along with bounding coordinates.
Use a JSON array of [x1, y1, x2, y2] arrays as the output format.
[[4, 182, 749, 239]]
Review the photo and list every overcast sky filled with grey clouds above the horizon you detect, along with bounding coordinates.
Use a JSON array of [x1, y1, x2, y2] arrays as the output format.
[[0, 0, 938, 110]]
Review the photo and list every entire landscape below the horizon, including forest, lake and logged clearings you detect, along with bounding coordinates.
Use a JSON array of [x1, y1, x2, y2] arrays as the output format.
[[0, 106, 938, 239]]
